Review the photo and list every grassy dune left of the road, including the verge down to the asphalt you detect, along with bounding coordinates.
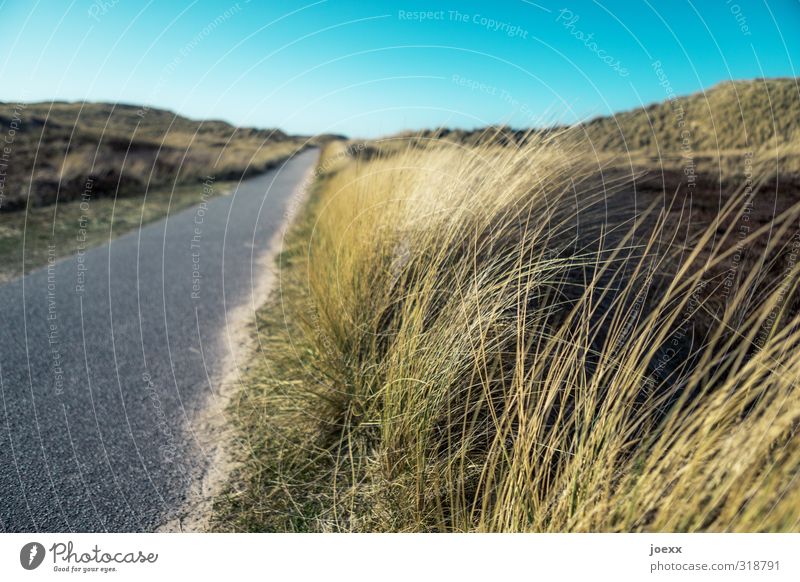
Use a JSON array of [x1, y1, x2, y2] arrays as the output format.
[[0, 102, 310, 282]]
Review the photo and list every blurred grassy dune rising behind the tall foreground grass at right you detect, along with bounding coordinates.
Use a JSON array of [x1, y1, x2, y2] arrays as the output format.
[[361, 78, 800, 188]]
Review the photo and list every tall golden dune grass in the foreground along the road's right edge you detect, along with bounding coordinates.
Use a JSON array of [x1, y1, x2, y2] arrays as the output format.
[[216, 134, 800, 531]]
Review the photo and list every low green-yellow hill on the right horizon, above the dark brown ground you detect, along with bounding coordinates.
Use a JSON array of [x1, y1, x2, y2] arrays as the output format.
[[365, 79, 800, 157]]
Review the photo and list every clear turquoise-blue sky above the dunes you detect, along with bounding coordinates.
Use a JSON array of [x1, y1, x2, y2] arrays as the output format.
[[0, 0, 800, 136]]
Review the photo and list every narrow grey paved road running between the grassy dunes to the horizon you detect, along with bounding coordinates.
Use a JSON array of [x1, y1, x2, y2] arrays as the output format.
[[0, 150, 317, 531]]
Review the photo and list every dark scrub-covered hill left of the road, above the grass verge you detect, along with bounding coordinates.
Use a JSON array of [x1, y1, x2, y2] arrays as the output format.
[[0, 102, 305, 211]]
